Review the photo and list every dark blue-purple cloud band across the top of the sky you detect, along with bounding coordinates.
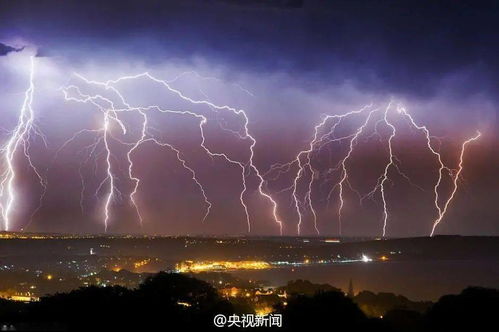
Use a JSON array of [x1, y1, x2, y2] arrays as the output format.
[[0, 0, 499, 98]]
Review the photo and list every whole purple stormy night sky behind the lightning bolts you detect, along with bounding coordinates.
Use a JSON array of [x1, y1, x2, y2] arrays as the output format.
[[0, 0, 499, 237]]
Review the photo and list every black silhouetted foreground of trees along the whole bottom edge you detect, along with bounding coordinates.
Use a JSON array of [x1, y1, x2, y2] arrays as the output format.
[[0, 272, 499, 331]]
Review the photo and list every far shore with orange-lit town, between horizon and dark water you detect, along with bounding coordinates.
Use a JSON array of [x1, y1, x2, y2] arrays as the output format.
[[0, 233, 495, 299]]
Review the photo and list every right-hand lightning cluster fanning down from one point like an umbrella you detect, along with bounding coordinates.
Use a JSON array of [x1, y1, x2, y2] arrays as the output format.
[[264, 101, 480, 237]]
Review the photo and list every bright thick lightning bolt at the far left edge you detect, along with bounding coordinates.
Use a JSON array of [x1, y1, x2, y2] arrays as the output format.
[[0, 57, 47, 230]]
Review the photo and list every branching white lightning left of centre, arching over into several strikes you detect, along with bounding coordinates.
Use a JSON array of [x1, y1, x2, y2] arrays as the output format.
[[58, 72, 282, 234]]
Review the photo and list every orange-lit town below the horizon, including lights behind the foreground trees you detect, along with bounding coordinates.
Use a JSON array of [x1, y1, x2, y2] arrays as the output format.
[[0, 233, 434, 322]]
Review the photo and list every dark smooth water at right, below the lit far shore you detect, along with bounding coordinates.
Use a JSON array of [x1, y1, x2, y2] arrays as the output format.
[[232, 260, 499, 301]]
